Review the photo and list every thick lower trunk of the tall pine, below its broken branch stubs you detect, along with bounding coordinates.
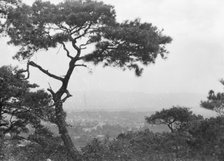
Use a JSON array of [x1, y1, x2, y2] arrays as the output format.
[[55, 101, 82, 161]]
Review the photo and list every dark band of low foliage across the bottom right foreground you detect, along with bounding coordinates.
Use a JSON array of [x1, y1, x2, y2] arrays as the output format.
[[82, 117, 224, 161]]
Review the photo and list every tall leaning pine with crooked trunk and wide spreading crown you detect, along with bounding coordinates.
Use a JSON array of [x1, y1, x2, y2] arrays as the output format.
[[1, 0, 171, 160]]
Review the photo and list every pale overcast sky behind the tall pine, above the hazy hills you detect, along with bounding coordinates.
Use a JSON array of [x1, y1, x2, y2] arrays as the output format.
[[0, 0, 224, 96]]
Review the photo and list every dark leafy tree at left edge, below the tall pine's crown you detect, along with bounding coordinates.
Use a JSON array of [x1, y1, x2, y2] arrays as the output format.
[[0, 66, 51, 137]]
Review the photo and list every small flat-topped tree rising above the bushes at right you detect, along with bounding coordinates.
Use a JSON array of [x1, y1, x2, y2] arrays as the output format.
[[145, 107, 203, 132]]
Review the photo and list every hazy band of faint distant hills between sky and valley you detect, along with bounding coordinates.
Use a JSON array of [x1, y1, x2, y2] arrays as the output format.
[[65, 91, 216, 116]]
